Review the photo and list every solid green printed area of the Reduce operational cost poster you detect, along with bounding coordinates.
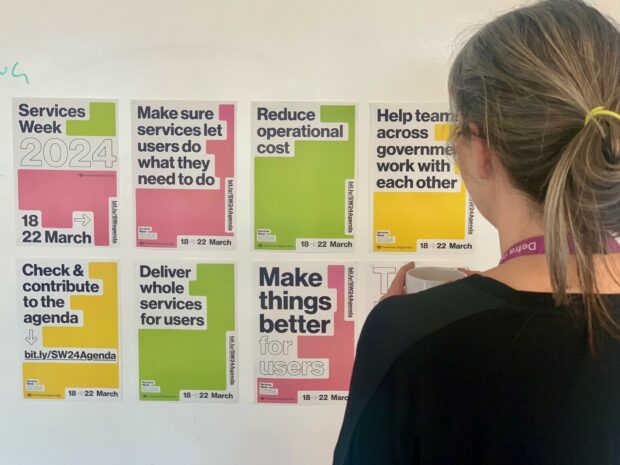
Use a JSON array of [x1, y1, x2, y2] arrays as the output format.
[[254, 105, 355, 250]]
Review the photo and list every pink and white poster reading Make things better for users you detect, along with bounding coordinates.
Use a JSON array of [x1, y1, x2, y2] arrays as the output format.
[[254, 262, 357, 404]]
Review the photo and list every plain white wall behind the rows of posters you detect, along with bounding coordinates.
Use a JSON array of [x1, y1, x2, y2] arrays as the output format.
[[0, 0, 620, 465]]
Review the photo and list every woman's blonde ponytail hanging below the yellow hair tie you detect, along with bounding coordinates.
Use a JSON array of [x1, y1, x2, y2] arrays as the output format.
[[543, 112, 620, 353]]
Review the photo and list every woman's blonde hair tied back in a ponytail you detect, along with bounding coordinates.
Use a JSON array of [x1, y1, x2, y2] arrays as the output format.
[[449, 0, 620, 352]]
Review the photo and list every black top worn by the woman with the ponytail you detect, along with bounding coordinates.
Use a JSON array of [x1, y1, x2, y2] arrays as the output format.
[[333, 275, 620, 465]]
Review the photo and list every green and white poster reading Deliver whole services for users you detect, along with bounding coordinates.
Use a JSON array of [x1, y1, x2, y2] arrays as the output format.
[[135, 260, 237, 402]]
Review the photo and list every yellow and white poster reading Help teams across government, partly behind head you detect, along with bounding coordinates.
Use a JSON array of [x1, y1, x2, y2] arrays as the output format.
[[370, 103, 475, 256]]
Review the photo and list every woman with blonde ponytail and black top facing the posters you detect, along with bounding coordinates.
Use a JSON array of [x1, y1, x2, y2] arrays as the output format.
[[334, 0, 620, 465]]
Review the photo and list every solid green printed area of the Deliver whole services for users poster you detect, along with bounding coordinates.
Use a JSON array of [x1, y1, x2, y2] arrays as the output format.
[[138, 264, 235, 400]]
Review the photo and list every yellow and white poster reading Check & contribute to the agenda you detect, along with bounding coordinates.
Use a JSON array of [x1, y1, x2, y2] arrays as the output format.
[[17, 258, 120, 400]]
